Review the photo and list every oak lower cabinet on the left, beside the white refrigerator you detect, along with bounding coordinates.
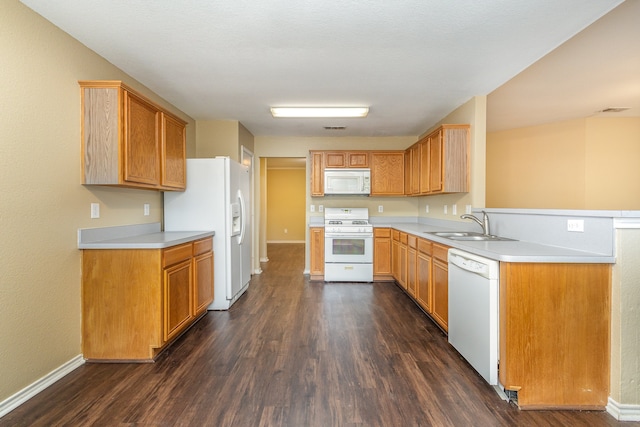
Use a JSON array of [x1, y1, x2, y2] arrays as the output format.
[[82, 237, 213, 362]]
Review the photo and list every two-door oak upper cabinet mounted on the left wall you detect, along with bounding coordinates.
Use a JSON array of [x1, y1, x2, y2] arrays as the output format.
[[79, 81, 186, 190]]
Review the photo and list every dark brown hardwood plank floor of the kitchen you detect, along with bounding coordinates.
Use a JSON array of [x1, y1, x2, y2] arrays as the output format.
[[0, 244, 640, 427]]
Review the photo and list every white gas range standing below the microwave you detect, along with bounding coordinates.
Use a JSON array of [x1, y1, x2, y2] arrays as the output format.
[[324, 208, 373, 282]]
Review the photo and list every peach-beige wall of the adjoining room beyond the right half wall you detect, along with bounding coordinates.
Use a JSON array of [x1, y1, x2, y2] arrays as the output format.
[[487, 117, 640, 210]]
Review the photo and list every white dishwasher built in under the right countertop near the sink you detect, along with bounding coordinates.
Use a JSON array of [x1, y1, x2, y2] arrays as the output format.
[[448, 249, 500, 385]]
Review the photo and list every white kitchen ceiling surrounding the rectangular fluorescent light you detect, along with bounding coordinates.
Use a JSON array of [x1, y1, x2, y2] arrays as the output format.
[[22, 0, 640, 136]]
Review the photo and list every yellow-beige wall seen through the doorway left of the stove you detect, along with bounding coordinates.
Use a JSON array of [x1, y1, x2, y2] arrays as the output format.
[[267, 169, 307, 242]]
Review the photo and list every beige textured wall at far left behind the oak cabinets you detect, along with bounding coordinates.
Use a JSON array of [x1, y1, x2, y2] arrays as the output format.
[[0, 0, 195, 402]]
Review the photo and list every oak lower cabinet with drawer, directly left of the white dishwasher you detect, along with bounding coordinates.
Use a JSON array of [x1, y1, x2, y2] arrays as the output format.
[[430, 243, 449, 332]]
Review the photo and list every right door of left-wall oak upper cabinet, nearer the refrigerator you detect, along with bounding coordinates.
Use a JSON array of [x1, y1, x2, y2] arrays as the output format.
[[161, 113, 187, 190]]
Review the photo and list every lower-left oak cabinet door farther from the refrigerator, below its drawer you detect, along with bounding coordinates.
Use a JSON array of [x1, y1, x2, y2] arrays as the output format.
[[164, 259, 192, 341]]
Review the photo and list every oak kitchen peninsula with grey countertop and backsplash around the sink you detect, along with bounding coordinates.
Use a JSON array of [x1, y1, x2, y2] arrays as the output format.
[[310, 209, 617, 409]]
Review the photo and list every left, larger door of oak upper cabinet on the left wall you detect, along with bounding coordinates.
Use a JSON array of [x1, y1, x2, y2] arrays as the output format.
[[122, 91, 160, 186]]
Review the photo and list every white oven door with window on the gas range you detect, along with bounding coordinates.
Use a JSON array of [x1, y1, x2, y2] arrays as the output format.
[[324, 233, 373, 264]]
